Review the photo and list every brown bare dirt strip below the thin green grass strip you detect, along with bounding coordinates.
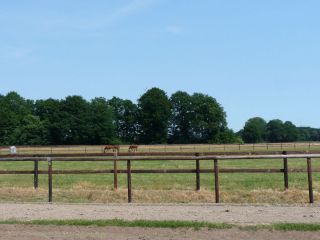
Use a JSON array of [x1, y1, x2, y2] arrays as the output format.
[[0, 225, 319, 240]]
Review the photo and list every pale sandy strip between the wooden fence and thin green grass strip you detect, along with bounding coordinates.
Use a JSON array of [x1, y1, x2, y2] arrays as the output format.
[[0, 203, 320, 225]]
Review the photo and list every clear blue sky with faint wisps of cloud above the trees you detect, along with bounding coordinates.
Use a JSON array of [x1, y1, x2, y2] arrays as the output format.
[[0, 0, 320, 130]]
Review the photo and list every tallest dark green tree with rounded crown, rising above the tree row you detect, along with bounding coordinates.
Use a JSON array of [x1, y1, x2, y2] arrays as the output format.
[[138, 88, 171, 144]]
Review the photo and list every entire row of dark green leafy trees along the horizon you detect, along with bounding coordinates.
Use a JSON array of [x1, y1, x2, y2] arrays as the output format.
[[0, 88, 320, 145]]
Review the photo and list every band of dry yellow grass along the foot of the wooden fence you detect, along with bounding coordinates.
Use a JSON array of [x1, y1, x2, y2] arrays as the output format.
[[0, 186, 320, 204]]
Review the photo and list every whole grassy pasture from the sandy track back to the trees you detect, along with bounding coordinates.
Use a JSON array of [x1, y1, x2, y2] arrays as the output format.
[[0, 144, 320, 204]]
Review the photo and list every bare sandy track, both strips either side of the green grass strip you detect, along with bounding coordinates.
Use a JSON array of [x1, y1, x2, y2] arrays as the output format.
[[0, 203, 320, 240]]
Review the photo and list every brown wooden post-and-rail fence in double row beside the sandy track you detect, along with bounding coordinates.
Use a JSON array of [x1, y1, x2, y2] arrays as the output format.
[[0, 152, 320, 203]]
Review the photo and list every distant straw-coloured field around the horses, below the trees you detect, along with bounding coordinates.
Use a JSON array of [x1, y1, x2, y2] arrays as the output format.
[[0, 142, 320, 154]]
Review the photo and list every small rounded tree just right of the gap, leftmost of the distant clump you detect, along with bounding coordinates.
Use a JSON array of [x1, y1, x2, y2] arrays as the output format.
[[241, 117, 267, 143]]
